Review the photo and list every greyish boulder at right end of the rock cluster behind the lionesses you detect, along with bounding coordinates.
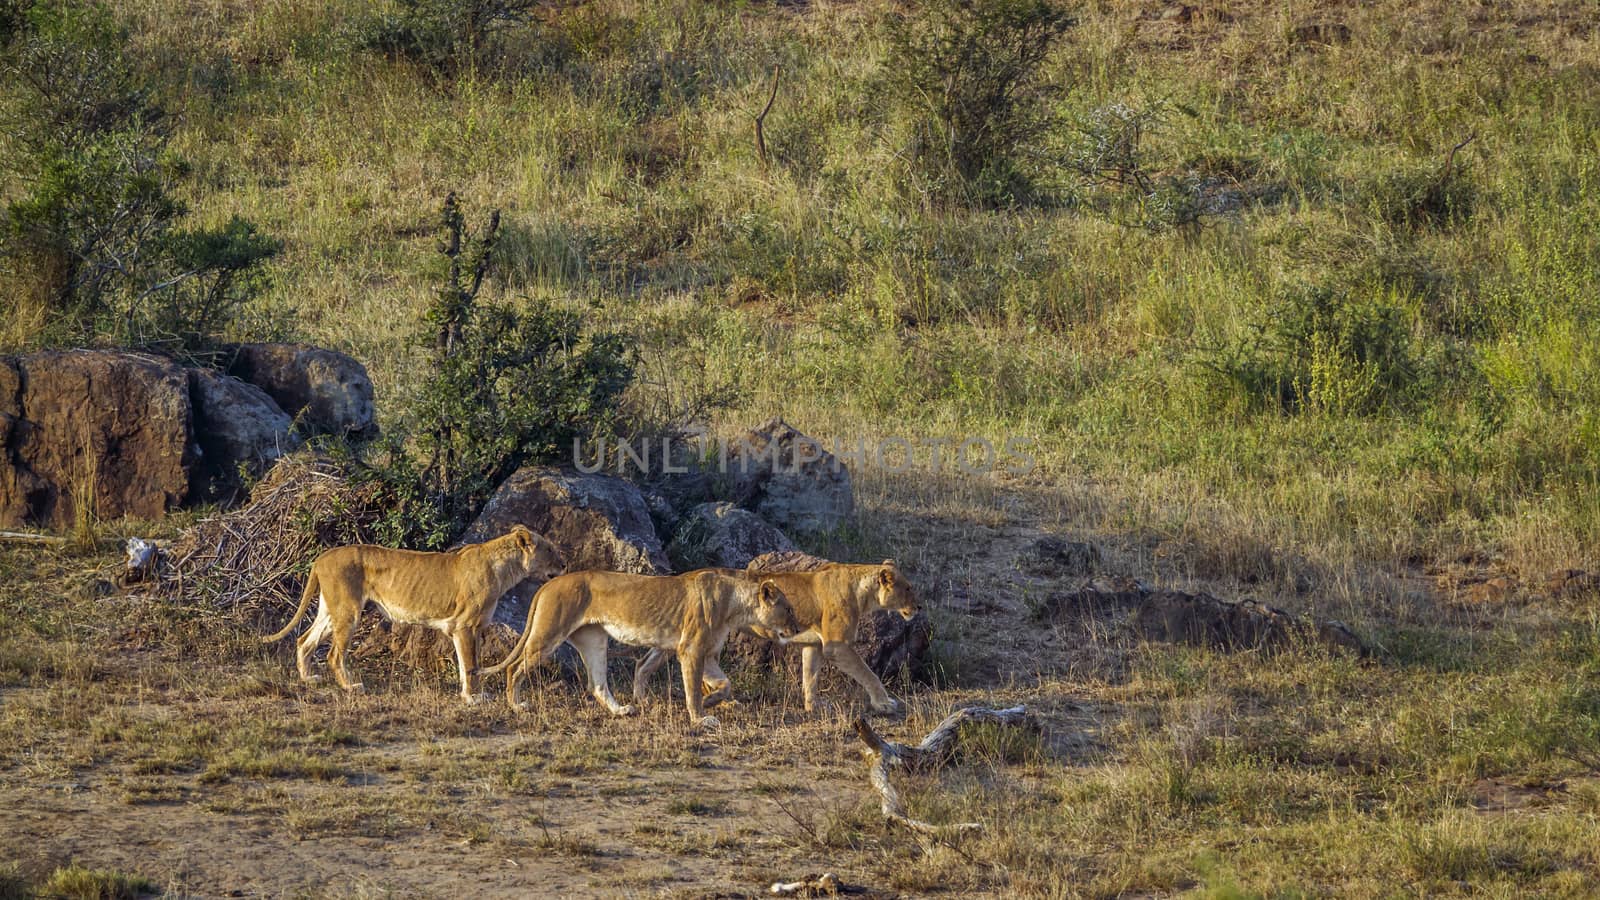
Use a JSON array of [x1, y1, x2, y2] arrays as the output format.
[[728, 418, 856, 533]]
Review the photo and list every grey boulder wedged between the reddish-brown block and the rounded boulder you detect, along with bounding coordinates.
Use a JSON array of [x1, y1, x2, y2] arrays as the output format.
[[189, 368, 299, 500]]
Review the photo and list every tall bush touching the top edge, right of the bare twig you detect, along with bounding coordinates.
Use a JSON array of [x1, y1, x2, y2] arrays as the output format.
[[885, 0, 1074, 202]]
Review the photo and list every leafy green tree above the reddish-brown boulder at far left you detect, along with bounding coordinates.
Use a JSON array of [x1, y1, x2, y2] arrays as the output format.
[[0, 0, 280, 349]]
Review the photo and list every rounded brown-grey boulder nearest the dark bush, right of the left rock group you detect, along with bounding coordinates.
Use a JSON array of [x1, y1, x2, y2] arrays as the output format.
[[227, 344, 378, 437]]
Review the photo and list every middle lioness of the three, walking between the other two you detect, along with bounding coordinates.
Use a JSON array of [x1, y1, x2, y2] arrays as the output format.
[[485, 569, 800, 725]]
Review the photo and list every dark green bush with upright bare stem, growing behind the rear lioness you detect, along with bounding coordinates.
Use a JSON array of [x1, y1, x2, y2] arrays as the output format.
[[392, 194, 634, 546]]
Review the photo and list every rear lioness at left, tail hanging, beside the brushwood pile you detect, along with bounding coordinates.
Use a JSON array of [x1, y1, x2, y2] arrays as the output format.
[[262, 525, 565, 703]]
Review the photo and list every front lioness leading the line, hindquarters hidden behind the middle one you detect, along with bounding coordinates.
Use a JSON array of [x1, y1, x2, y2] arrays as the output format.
[[634, 559, 920, 716]]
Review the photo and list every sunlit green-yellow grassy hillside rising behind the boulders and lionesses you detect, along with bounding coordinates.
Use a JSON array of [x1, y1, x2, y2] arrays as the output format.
[[9, 0, 1600, 582]]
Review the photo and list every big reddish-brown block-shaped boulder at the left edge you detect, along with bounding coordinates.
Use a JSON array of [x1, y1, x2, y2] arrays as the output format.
[[0, 351, 195, 528]]
